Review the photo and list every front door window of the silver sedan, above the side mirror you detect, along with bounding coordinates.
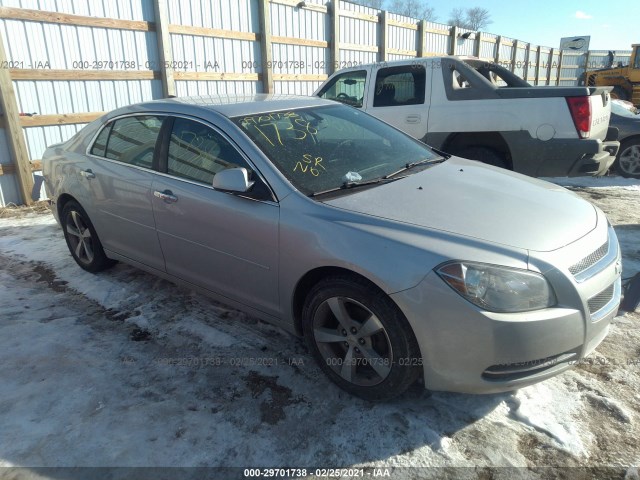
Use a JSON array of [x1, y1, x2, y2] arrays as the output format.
[[167, 118, 251, 185]]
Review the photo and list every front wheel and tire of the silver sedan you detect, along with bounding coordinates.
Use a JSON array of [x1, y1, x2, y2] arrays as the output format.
[[302, 275, 422, 401]]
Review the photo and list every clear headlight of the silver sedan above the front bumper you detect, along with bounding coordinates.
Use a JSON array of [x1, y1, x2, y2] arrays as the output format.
[[436, 262, 556, 312]]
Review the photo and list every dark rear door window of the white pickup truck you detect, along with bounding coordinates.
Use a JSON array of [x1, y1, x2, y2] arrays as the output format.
[[373, 64, 427, 107]]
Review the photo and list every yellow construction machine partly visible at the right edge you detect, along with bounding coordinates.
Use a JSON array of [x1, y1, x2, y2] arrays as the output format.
[[586, 43, 640, 107]]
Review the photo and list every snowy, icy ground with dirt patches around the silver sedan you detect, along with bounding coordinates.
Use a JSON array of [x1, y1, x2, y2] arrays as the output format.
[[0, 177, 640, 478]]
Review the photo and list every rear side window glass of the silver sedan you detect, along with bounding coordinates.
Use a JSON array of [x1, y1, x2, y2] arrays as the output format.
[[102, 115, 163, 168]]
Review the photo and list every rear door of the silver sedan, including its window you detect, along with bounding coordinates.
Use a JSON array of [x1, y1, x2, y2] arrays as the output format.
[[80, 115, 167, 271]]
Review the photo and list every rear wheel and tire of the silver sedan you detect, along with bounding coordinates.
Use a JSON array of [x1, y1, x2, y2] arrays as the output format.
[[60, 200, 116, 273]]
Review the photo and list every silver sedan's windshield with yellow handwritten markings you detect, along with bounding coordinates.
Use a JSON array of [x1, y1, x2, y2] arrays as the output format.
[[232, 105, 441, 195]]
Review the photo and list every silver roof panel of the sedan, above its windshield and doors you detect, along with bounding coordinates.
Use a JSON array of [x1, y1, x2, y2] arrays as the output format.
[[125, 93, 336, 118]]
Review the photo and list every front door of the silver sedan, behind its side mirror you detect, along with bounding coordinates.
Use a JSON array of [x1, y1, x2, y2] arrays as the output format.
[[152, 117, 280, 314]]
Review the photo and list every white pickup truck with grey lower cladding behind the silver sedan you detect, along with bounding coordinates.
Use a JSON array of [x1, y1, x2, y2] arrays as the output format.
[[315, 56, 620, 176]]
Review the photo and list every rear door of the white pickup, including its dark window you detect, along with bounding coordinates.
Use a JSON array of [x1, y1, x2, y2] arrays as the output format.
[[366, 62, 431, 139]]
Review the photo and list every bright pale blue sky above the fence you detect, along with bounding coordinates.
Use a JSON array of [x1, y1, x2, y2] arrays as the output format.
[[426, 0, 640, 50]]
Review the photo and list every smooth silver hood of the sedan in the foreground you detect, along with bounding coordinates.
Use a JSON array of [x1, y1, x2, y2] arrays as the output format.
[[324, 157, 597, 251]]
